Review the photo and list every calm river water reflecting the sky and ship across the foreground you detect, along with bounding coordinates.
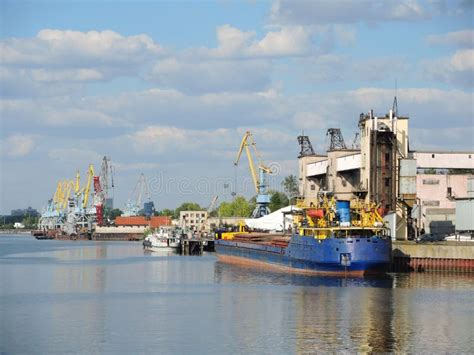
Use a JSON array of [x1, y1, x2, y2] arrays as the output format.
[[0, 236, 474, 354]]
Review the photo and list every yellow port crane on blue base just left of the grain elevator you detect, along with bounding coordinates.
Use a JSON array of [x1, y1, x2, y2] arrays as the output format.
[[234, 131, 271, 218]]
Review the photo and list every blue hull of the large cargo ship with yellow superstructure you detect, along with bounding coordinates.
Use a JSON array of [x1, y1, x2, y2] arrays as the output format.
[[215, 235, 392, 276]]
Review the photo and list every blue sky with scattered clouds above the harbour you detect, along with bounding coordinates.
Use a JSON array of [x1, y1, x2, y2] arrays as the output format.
[[0, 0, 474, 214]]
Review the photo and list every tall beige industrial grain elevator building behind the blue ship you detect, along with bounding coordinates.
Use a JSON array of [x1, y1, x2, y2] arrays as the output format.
[[298, 98, 474, 240]]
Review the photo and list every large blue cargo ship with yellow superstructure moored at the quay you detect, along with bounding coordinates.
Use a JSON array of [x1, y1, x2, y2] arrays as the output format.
[[215, 193, 392, 277]]
